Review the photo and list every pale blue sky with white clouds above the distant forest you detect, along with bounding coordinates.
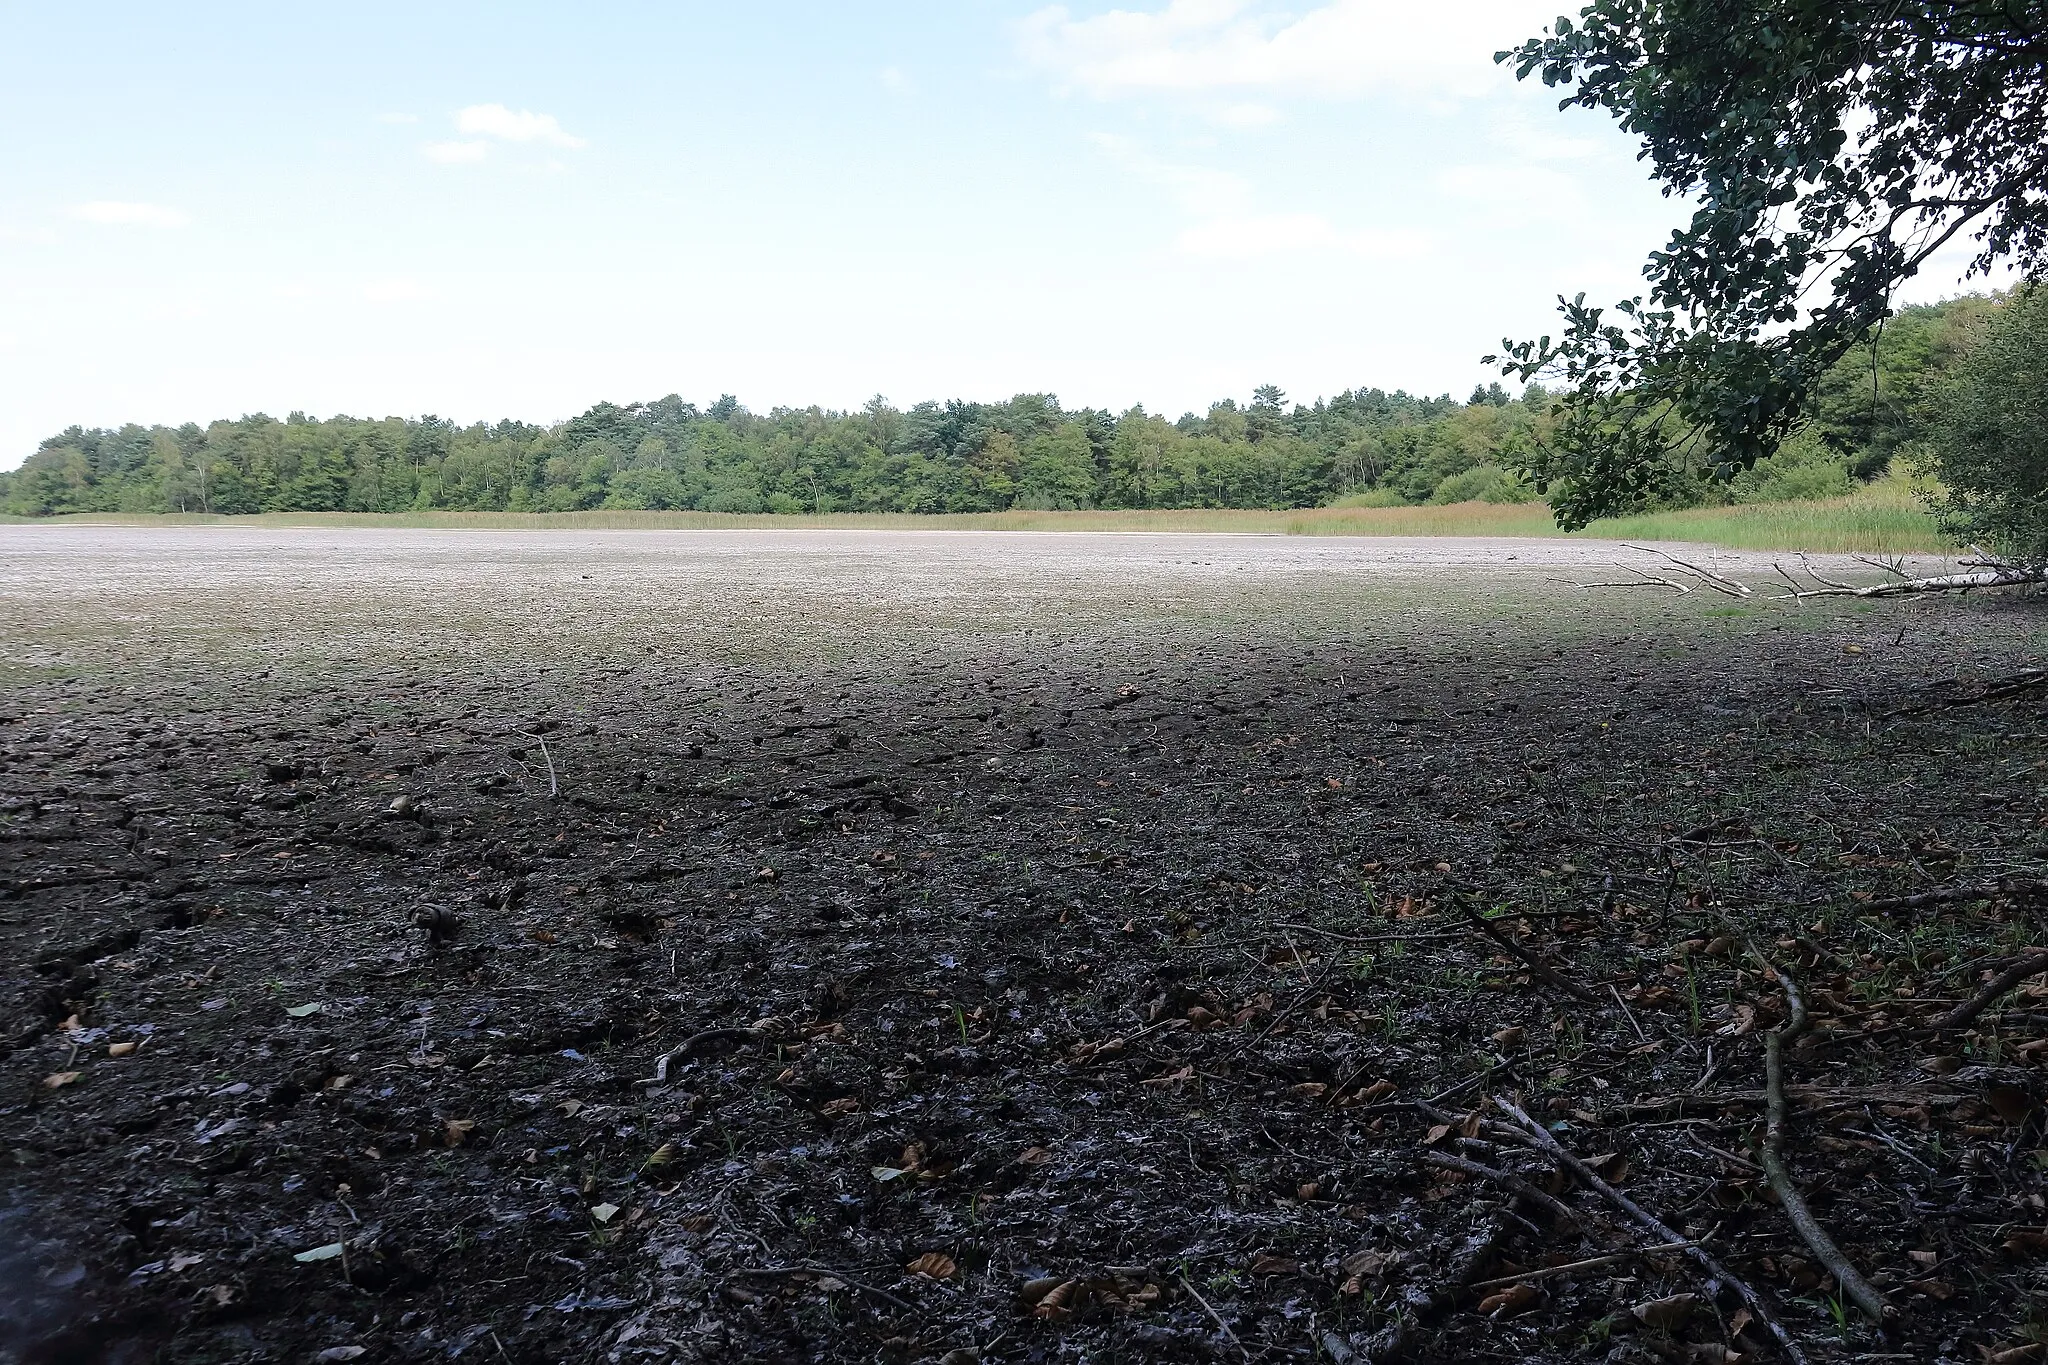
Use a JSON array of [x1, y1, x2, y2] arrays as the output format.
[[0, 0, 1998, 469]]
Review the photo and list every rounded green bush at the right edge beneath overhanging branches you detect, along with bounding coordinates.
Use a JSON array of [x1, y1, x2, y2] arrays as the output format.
[[1921, 289, 2048, 567]]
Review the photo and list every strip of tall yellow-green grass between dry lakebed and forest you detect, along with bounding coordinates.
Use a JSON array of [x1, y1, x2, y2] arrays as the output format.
[[28, 479, 1950, 555]]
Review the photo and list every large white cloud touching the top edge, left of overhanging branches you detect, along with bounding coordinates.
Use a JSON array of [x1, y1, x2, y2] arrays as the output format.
[[1018, 0, 1554, 98]]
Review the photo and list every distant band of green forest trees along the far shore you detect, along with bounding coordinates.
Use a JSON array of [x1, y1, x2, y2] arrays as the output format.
[[0, 295, 2003, 516]]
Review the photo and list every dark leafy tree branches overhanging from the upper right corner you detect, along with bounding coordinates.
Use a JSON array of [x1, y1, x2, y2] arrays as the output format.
[[1499, 0, 2048, 526]]
